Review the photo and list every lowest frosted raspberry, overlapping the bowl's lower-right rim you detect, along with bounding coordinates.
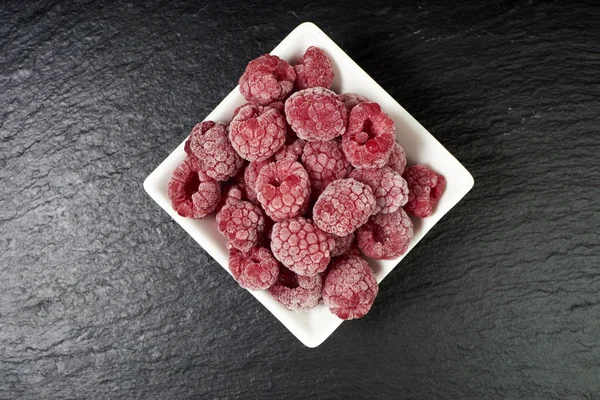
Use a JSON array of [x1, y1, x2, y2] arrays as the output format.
[[323, 255, 379, 319]]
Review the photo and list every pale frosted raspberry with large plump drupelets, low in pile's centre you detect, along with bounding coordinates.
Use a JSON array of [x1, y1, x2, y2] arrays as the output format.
[[271, 218, 335, 276]]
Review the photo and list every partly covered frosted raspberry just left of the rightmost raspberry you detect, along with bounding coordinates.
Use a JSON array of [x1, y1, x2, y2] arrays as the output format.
[[350, 167, 408, 214]]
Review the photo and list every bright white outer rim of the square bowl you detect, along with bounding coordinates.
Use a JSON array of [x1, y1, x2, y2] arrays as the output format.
[[144, 22, 474, 348]]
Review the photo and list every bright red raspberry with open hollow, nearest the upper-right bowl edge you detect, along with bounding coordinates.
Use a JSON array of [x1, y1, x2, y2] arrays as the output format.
[[342, 103, 396, 169]]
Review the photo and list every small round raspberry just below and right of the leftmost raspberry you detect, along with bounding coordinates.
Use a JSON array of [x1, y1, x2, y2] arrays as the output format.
[[217, 201, 265, 252]]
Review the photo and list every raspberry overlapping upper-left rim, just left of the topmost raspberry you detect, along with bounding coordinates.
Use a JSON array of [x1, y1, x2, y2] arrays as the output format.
[[239, 54, 296, 105]]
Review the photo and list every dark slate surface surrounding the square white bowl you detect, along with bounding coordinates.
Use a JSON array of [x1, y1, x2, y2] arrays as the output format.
[[0, 0, 600, 399]]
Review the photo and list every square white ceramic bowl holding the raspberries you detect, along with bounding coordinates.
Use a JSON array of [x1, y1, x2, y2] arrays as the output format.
[[144, 22, 474, 347]]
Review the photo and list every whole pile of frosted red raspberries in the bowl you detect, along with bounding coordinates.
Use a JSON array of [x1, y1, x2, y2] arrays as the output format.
[[168, 47, 446, 319]]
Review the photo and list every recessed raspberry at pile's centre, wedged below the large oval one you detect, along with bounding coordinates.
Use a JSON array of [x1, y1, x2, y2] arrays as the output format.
[[301, 140, 352, 199]]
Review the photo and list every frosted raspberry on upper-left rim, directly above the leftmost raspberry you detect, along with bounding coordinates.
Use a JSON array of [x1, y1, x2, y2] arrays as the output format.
[[184, 121, 244, 181]]
